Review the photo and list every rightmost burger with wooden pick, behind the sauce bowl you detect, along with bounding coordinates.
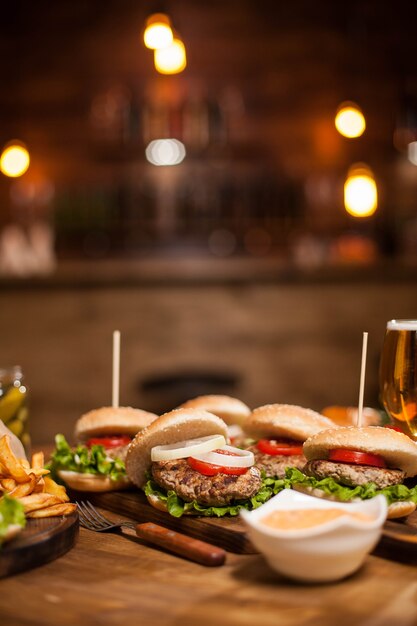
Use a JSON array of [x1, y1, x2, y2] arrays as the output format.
[[287, 426, 417, 518]]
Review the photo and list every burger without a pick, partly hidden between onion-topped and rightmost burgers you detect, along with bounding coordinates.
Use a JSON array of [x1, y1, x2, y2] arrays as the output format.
[[245, 404, 335, 478]]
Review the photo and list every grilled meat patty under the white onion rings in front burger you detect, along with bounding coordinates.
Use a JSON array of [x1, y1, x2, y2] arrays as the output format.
[[151, 459, 262, 506]]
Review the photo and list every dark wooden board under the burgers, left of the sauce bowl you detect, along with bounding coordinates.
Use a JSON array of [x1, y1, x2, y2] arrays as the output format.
[[88, 491, 257, 554]]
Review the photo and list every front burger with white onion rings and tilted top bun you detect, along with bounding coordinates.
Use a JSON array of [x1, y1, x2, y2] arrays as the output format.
[[126, 408, 273, 517]]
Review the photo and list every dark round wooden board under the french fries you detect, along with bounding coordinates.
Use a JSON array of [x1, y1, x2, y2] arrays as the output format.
[[0, 512, 78, 578]]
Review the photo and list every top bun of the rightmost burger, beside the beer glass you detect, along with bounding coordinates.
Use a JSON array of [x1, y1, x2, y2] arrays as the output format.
[[303, 426, 417, 476]]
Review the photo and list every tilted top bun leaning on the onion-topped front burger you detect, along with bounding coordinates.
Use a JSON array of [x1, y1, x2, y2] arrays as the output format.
[[125, 409, 227, 487]]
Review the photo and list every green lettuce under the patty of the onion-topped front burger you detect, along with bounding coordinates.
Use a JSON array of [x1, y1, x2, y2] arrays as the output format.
[[144, 475, 288, 517]]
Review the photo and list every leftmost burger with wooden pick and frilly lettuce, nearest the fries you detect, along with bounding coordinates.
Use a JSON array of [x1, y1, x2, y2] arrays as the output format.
[[48, 407, 158, 491]]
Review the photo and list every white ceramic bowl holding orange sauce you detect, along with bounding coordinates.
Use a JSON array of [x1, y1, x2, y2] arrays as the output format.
[[241, 489, 388, 582]]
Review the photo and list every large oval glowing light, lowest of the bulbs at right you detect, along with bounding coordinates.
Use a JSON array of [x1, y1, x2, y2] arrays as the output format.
[[344, 164, 378, 217]]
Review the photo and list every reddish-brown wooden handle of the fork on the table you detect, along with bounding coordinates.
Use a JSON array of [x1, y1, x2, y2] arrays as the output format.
[[136, 522, 226, 567]]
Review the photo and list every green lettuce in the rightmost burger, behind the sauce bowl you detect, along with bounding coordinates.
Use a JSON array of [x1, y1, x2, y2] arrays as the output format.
[[285, 468, 417, 504]]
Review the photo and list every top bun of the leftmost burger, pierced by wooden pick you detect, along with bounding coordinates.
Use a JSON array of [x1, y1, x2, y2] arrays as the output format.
[[75, 406, 158, 441]]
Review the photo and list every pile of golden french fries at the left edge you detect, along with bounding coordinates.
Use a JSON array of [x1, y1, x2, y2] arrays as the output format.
[[0, 435, 77, 518]]
